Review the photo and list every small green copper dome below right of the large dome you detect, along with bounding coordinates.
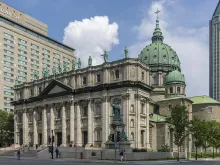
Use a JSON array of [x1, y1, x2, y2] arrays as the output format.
[[165, 68, 185, 84]]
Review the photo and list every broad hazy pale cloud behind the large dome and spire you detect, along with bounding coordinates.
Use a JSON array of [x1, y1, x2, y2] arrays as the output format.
[[129, 0, 209, 96]]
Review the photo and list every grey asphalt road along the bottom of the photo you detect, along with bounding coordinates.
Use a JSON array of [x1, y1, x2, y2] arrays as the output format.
[[0, 157, 220, 165]]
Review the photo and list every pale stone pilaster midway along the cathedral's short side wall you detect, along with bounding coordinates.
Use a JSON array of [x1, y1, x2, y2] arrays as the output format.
[[135, 94, 141, 148]]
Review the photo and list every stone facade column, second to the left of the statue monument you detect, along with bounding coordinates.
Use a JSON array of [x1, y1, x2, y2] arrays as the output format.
[[87, 99, 92, 147]]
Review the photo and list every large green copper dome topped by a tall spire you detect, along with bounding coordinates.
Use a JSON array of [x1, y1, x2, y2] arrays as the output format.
[[138, 20, 180, 70]]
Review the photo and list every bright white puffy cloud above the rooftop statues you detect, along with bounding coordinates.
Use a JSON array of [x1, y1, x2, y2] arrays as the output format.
[[63, 16, 119, 66]]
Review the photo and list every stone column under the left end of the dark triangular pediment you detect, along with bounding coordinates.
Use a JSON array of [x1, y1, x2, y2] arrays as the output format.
[[42, 106, 48, 146]]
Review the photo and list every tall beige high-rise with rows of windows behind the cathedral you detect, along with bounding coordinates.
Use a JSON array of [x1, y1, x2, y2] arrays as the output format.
[[0, 2, 74, 111]]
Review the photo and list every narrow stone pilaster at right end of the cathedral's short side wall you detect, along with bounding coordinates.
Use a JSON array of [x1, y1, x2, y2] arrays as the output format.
[[145, 99, 151, 149]]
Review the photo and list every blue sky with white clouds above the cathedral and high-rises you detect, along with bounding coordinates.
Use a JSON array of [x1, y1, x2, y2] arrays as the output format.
[[2, 0, 218, 97]]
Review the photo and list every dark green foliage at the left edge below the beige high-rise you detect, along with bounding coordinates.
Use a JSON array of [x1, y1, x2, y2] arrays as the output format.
[[0, 110, 14, 145]]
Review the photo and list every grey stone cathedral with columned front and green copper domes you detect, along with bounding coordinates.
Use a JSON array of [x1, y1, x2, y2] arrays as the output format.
[[12, 16, 220, 151]]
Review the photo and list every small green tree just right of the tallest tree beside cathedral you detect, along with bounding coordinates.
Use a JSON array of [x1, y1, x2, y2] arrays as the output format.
[[190, 118, 205, 160]]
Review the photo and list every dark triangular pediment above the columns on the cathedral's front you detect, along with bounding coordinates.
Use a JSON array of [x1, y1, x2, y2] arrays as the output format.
[[39, 80, 72, 96]]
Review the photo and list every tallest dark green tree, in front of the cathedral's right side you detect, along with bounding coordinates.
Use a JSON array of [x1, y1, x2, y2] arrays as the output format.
[[167, 104, 189, 161]]
